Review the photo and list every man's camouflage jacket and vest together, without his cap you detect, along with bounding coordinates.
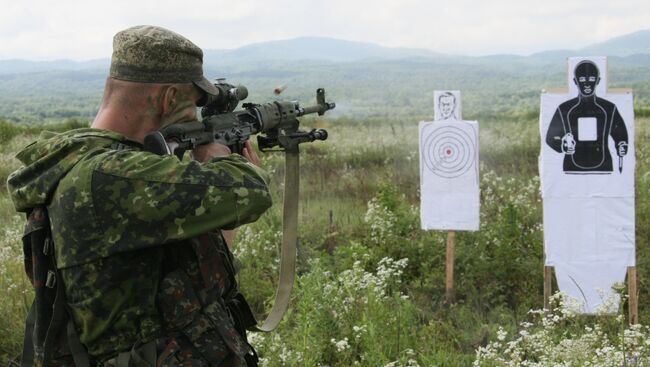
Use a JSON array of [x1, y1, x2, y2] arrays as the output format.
[[8, 25, 271, 366]]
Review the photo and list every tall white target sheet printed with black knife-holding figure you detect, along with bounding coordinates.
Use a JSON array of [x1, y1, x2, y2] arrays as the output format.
[[539, 57, 636, 313]]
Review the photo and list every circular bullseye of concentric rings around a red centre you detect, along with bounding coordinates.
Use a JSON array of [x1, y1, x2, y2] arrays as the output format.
[[422, 125, 476, 178]]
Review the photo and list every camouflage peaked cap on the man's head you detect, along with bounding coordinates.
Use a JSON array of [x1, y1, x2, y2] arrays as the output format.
[[110, 25, 219, 95]]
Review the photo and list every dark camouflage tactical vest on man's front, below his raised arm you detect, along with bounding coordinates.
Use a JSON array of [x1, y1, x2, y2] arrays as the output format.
[[158, 231, 257, 366]]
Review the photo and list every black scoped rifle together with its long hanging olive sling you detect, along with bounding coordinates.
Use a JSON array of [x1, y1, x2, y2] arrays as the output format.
[[144, 80, 336, 331]]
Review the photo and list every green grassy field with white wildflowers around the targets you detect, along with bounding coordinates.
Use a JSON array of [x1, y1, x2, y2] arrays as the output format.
[[0, 114, 650, 366]]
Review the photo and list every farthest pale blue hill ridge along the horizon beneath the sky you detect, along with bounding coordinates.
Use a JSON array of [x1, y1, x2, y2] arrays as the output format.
[[0, 30, 650, 75]]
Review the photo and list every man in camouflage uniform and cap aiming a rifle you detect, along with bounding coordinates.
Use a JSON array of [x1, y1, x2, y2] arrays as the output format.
[[8, 26, 271, 367]]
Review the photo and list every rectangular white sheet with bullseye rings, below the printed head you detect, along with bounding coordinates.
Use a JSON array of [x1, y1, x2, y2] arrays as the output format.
[[419, 121, 480, 231]]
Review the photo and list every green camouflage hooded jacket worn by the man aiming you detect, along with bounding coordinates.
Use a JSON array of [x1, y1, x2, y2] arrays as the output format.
[[8, 129, 271, 360]]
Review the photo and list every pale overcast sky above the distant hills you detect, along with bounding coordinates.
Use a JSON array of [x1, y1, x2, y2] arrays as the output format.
[[0, 0, 650, 60]]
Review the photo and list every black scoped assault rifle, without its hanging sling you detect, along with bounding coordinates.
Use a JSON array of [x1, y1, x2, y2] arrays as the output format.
[[144, 79, 336, 158]]
